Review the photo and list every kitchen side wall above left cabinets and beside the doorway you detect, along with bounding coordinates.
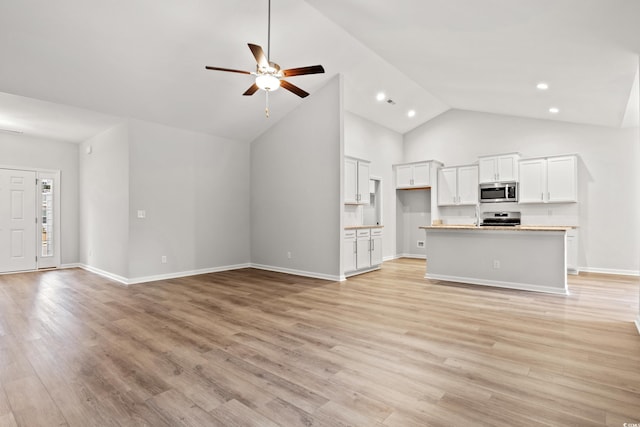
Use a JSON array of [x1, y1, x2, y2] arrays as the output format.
[[344, 112, 403, 258]]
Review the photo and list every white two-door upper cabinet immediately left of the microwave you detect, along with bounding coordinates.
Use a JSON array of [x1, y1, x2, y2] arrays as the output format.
[[438, 165, 478, 206]]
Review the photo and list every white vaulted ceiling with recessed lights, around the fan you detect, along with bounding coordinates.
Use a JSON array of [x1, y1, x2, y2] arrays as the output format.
[[0, 0, 640, 141]]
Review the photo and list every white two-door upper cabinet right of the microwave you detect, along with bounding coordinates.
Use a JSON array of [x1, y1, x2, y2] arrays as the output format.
[[519, 155, 578, 203]]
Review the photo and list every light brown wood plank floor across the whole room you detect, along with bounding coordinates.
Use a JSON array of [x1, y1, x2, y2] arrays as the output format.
[[0, 259, 640, 427]]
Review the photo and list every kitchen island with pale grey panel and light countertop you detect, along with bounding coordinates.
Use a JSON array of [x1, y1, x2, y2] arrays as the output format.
[[420, 225, 572, 294]]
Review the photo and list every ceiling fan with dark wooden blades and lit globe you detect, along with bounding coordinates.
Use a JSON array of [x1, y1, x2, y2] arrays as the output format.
[[205, 0, 324, 117]]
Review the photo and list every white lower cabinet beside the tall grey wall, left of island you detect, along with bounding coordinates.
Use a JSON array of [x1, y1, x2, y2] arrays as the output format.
[[342, 227, 383, 276]]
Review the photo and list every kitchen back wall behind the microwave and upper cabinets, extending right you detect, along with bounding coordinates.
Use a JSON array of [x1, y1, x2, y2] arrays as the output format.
[[404, 110, 640, 274]]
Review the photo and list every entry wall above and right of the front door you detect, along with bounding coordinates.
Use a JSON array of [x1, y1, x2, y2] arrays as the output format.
[[0, 132, 78, 265]]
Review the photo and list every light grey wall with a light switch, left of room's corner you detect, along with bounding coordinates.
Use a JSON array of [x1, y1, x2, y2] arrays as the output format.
[[126, 120, 249, 280]]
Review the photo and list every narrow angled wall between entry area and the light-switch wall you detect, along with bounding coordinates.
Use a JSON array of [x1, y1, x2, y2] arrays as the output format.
[[78, 123, 129, 278]]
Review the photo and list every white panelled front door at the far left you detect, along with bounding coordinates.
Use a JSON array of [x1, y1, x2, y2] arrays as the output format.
[[0, 169, 37, 273]]
